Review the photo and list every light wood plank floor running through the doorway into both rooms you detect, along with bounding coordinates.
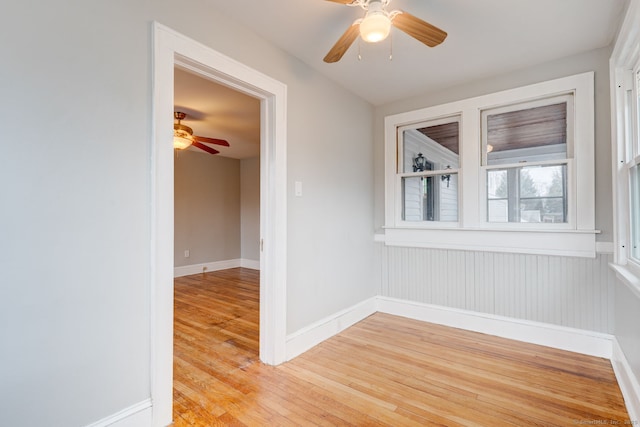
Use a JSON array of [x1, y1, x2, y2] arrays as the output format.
[[174, 268, 628, 427]]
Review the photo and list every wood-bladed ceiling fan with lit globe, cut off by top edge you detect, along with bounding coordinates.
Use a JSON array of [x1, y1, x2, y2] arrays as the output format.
[[324, 0, 447, 63]]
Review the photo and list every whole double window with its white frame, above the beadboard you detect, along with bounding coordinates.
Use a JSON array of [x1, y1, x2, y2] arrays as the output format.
[[384, 73, 596, 257]]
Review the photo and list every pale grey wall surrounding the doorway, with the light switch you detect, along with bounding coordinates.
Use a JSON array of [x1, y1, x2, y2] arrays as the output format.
[[0, 0, 374, 427]]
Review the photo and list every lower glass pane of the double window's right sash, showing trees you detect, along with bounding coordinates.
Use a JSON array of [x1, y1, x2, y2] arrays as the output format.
[[487, 164, 567, 223]]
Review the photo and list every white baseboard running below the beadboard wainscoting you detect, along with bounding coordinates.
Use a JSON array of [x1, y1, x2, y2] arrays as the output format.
[[378, 296, 613, 359]]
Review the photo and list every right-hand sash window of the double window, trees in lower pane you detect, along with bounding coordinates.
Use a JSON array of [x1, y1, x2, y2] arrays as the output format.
[[481, 95, 573, 223]]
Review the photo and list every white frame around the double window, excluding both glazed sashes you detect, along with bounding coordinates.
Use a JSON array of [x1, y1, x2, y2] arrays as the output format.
[[384, 72, 598, 257]]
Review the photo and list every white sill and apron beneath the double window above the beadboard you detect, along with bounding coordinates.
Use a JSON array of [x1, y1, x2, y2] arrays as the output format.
[[375, 228, 598, 258]]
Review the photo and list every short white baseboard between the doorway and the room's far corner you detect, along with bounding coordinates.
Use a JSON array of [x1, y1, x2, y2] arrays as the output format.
[[286, 297, 377, 361]]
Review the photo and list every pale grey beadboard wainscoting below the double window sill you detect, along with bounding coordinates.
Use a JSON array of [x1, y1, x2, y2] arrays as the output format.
[[375, 242, 616, 334]]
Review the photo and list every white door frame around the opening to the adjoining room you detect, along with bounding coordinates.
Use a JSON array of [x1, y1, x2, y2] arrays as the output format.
[[149, 22, 287, 427]]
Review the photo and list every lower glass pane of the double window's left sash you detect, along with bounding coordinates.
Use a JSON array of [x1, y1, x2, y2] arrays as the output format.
[[402, 173, 458, 222]]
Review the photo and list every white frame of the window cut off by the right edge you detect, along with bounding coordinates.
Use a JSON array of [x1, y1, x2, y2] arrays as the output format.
[[609, 2, 640, 295]]
